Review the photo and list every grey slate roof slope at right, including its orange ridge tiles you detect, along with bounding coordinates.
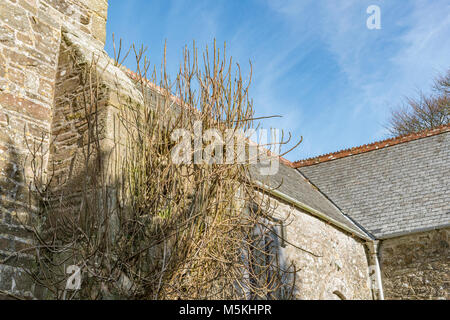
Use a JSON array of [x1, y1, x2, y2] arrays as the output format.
[[294, 126, 450, 239]]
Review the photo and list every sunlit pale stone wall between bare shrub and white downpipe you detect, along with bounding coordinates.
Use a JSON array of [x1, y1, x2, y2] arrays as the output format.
[[272, 195, 373, 300]]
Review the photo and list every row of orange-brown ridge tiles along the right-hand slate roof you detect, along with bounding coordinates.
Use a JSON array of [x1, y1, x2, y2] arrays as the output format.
[[292, 124, 450, 168]]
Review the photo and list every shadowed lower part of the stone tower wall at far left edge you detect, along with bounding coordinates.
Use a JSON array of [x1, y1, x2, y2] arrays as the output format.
[[0, 124, 36, 299]]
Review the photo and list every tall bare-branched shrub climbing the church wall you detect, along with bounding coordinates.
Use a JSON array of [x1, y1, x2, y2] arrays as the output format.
[[23, 39, 296, 299]]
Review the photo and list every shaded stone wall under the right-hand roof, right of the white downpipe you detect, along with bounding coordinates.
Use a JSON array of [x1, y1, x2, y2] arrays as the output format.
[[380, 228, 450, 300]]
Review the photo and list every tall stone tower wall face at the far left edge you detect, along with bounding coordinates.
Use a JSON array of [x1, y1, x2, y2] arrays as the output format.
[[0, 0, 107, 297]]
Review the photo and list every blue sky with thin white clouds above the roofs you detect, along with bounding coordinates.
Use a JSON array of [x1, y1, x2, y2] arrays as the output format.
[[106, 0, 450, 161]]
